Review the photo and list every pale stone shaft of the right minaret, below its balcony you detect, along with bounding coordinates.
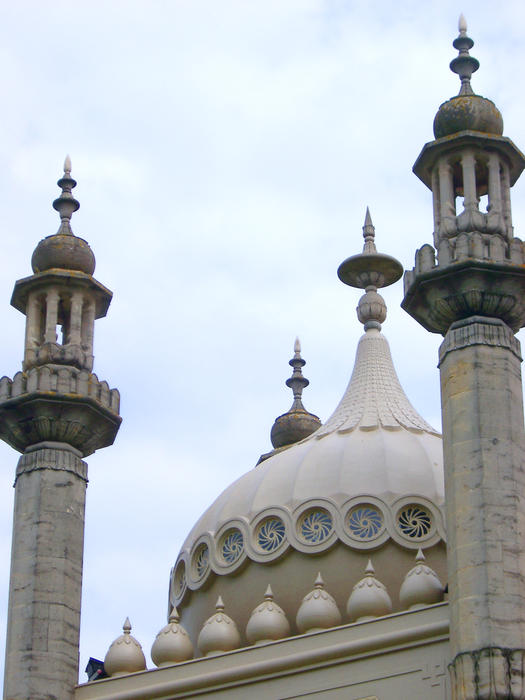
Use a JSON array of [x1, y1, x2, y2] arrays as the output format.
[[440, 317, 525, 700]]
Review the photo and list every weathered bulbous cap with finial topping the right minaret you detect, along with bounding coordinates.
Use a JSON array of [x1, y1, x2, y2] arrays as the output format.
[[434, 15, 503, 139]]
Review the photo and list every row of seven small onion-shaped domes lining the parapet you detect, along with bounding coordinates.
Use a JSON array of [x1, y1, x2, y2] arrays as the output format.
[[104, 550, 444, 676]]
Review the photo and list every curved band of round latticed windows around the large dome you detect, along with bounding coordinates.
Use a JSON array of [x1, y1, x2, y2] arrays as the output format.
[[171, 496, 445, 604]]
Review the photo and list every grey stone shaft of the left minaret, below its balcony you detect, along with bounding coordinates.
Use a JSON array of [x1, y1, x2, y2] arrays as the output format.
[[4, 443, 87, 700]]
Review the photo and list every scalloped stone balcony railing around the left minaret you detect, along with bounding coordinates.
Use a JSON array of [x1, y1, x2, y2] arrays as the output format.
[[0, 366, 120, 413]]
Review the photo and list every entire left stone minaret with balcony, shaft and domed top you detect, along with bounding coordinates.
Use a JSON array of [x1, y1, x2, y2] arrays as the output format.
[[0, 158, 121, 700]]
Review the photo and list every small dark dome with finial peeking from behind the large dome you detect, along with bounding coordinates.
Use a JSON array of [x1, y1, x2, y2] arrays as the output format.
[[270, 338, 321, 448]]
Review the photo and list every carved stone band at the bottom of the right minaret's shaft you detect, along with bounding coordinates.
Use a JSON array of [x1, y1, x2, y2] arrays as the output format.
[[448, 647, 525, 700]]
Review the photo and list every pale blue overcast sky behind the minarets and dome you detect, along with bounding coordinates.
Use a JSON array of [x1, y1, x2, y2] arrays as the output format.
[[0, 0, 525, 681]]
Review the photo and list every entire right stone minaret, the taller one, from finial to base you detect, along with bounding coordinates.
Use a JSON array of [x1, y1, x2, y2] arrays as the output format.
[[402, 17, 525, 700]]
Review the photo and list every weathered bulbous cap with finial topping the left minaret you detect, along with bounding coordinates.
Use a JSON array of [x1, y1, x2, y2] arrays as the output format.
[[31, 156, 95, 275]]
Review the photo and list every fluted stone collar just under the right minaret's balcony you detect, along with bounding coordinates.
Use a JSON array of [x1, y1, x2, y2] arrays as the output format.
[[439, 316, 522, 365]]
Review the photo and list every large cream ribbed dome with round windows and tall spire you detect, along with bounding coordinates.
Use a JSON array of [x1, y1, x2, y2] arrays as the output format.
[[170, 211, 446, 643]]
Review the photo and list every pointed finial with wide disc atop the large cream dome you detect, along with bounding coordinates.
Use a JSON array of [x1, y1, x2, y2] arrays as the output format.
[[337, 207, 403, 331]]
